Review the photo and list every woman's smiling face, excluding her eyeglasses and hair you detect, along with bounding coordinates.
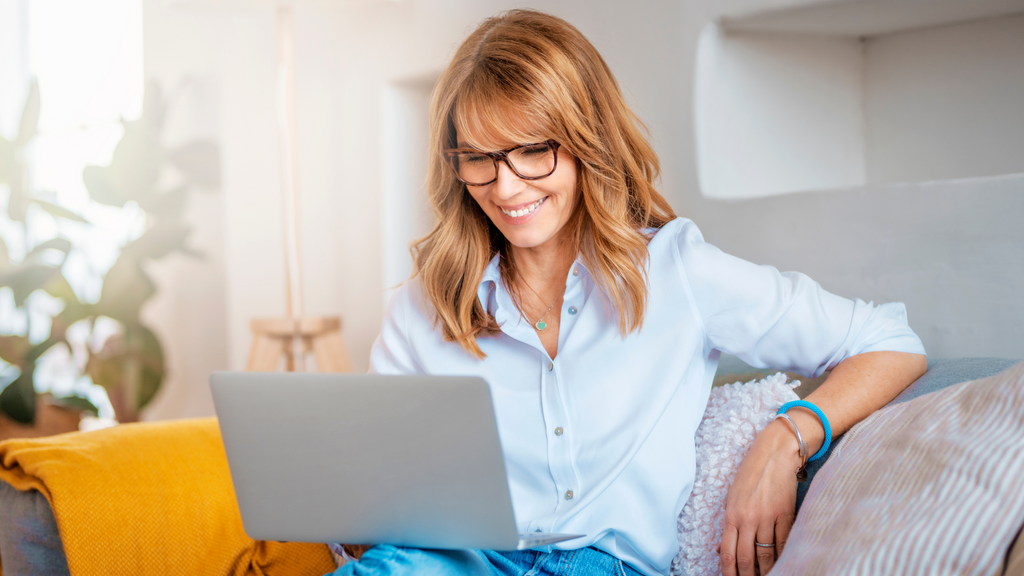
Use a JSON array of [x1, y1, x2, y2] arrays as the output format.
[[457, 126, 578, 248]]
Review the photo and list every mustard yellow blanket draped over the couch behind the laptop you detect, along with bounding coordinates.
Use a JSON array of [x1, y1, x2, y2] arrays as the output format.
[[0, 418, 335, 576]]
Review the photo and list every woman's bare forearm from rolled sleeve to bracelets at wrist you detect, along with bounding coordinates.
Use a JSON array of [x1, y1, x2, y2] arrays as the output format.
[[773, 352, 928, 454]]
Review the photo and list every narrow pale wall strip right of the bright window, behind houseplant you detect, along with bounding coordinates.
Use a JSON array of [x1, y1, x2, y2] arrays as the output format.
[[142, 2, 229, 419]]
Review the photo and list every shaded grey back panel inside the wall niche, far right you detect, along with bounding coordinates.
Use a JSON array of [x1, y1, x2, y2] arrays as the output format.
[[864, 14, 1024, 182]]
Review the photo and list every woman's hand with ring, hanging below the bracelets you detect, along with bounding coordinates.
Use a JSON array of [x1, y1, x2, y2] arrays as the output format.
[[719, 420, 802, 576]]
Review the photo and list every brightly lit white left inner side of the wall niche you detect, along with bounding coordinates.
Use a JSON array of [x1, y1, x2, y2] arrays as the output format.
[[694, 24, 864, 200]]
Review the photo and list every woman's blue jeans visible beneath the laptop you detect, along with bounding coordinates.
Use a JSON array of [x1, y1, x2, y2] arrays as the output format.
[[330, 544, 640, 576]]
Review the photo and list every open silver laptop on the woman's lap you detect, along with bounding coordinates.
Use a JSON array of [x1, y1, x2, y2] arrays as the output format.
[[210, 372, 581, 550]]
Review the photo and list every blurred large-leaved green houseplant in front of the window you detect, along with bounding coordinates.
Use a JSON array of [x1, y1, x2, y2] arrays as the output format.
[[0, 82, 220, 423]]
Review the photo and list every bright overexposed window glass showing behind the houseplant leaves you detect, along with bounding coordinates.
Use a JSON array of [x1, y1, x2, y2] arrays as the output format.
[[0, 0, 145, 416]]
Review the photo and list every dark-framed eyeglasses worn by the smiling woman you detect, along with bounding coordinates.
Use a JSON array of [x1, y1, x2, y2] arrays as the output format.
[[443, 140, 558, 186]]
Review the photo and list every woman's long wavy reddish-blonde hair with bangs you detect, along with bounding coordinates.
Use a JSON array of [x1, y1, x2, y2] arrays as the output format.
[[412, 10, 676, 359]]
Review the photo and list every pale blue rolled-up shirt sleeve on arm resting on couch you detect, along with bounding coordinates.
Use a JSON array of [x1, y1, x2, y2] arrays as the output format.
[[678, 221, 925, 377]]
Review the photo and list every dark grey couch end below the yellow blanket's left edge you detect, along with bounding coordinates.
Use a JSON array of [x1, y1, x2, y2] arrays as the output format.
[[0, 481, 69, 576]]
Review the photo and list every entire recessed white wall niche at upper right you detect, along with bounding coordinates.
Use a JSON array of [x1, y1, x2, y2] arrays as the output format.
[[694, 10, 1024, 199]]
